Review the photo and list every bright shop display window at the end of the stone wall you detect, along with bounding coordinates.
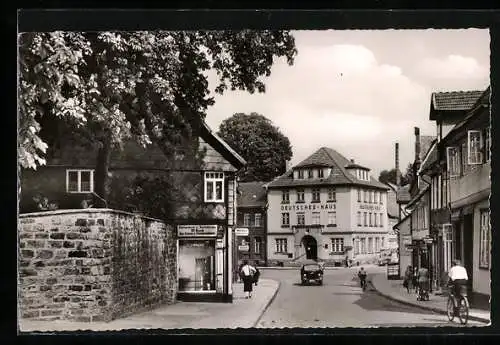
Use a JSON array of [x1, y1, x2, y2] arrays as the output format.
[[178, 239, 215, 291]]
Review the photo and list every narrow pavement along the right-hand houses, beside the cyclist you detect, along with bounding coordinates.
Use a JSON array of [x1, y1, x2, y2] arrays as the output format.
[[371, 274, 490, 324]]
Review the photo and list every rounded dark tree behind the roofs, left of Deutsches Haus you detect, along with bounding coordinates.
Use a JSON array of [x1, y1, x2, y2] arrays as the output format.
[[218, 113, 292, 181]]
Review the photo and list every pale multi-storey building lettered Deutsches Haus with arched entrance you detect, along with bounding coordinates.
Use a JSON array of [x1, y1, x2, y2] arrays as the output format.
[[267, 147, 388, 265]]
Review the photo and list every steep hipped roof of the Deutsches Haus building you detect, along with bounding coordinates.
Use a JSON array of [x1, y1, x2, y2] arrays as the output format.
[[268, 147, 389, 190]]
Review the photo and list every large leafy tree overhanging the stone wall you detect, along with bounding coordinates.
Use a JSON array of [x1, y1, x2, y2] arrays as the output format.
[[18, 30, 297, 202]]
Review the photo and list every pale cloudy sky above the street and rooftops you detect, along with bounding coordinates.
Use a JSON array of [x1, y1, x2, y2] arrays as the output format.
[[202, 29, 490, 178]]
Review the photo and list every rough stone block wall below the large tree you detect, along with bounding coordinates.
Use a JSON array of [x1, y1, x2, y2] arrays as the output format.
[[18, 209, 177, 321]]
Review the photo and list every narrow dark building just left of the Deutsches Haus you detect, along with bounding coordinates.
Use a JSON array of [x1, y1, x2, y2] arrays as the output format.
[[235, 182, 267, 268]]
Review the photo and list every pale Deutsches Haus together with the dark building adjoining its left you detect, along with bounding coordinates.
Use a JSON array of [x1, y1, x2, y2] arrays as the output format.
[[235, 147, 398, 266]]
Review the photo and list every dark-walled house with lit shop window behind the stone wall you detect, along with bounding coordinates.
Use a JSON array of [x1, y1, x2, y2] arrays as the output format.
[[20, 120, 246, 302]]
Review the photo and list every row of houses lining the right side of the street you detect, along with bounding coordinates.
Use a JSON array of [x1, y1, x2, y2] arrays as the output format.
[[394, 87, 491, 302]]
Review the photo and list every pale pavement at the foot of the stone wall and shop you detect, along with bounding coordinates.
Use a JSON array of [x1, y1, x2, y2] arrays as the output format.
[[19, 279, 279, 332]]
